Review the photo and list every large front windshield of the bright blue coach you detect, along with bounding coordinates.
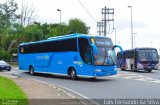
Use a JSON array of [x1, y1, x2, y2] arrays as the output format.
[[94, 38, 116, 65]]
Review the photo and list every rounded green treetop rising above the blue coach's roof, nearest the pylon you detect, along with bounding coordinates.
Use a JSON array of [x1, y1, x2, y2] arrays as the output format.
[[68, 18, 88, 34]]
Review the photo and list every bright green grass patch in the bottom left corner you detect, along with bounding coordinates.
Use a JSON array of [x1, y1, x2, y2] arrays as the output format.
[[0, 76, 28, 105]]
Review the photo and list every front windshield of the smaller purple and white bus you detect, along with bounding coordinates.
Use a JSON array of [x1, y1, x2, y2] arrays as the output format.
[[138, 49, 158, 61]]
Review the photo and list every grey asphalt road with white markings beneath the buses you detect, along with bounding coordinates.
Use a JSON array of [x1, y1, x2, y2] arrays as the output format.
[[2, 69, 160, 104]]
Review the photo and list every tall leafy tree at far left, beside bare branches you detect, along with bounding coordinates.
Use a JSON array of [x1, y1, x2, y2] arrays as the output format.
[[0, 0, 18, 51]]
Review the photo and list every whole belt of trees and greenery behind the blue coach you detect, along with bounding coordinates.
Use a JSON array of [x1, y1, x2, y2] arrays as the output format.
[[0, 0, 89, 61]]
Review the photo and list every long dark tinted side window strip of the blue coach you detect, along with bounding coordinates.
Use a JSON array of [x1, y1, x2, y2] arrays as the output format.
[[19, 38, 77, 54]]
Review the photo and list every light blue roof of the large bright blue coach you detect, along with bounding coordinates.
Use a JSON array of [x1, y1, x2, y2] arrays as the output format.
[[20, 33, 108, 45]]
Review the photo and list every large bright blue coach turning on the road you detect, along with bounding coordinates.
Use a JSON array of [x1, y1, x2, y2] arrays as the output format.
[[18, 33, 121, 79]]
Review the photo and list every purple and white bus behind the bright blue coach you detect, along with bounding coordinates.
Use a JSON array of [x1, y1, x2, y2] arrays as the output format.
[[117, 48, 159, 72]]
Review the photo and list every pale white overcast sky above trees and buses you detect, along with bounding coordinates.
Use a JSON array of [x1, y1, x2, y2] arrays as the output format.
[[2, 0, 160, 52]]
